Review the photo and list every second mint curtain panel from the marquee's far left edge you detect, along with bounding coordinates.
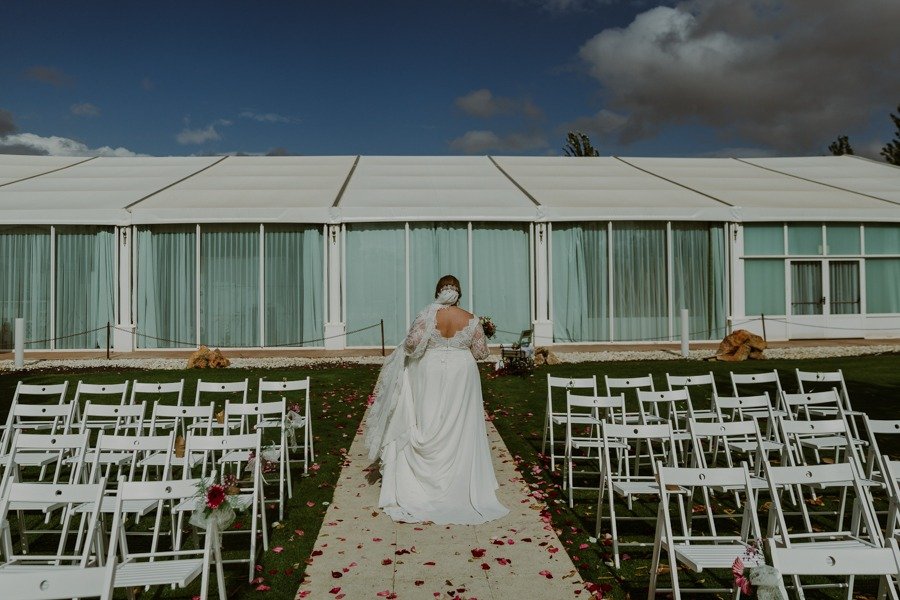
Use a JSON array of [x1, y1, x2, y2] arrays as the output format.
[[56, 226, 116, 348]]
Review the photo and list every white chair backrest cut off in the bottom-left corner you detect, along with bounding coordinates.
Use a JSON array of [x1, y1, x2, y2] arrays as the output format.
[[0, 563, 116, 600]]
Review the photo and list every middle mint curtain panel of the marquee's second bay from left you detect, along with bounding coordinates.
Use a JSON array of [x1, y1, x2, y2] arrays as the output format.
[[200, 225, 260, 348]]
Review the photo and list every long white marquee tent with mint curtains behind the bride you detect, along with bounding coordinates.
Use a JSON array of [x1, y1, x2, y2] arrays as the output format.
[[0, 155, 900, 350]]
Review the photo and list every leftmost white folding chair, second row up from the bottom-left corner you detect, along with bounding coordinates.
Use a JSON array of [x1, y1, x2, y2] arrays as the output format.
[[0, 478, 106, 572]]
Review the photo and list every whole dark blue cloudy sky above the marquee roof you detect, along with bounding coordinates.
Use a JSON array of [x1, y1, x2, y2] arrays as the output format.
[[0, 0, 900, 157]]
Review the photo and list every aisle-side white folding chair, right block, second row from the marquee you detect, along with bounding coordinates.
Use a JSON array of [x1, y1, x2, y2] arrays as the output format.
[[563, 390, 625, 507]]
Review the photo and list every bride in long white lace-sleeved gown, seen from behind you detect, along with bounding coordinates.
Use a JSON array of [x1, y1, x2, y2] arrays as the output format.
[[366, 275, 509, 524]]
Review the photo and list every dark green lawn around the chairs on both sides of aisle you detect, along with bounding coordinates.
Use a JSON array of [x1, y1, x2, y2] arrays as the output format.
[[0, 354, 900, 598]]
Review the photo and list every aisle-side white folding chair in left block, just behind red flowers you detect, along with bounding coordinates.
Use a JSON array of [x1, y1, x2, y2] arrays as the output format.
[[175, 431, 269, 580]]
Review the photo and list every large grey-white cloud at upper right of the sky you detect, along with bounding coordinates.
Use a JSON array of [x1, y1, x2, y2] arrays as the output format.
[[580, 0, 900, 153]]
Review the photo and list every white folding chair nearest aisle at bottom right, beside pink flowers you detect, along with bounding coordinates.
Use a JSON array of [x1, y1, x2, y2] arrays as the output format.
[[647, 464, 763, 599]]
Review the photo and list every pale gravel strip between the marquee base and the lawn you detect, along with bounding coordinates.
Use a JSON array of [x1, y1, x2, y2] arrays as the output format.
[[0, 345, 900, 372]]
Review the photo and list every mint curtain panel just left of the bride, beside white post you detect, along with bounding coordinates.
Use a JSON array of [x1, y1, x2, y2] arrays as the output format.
[[344, 223, 404, 346]]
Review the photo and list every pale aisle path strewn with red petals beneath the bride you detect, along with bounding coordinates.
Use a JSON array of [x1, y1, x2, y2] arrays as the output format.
[[297, 422, 590, 600]]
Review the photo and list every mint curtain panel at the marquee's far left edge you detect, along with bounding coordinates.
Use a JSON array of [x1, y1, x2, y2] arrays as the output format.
[[0, 225, 50, 350]]
